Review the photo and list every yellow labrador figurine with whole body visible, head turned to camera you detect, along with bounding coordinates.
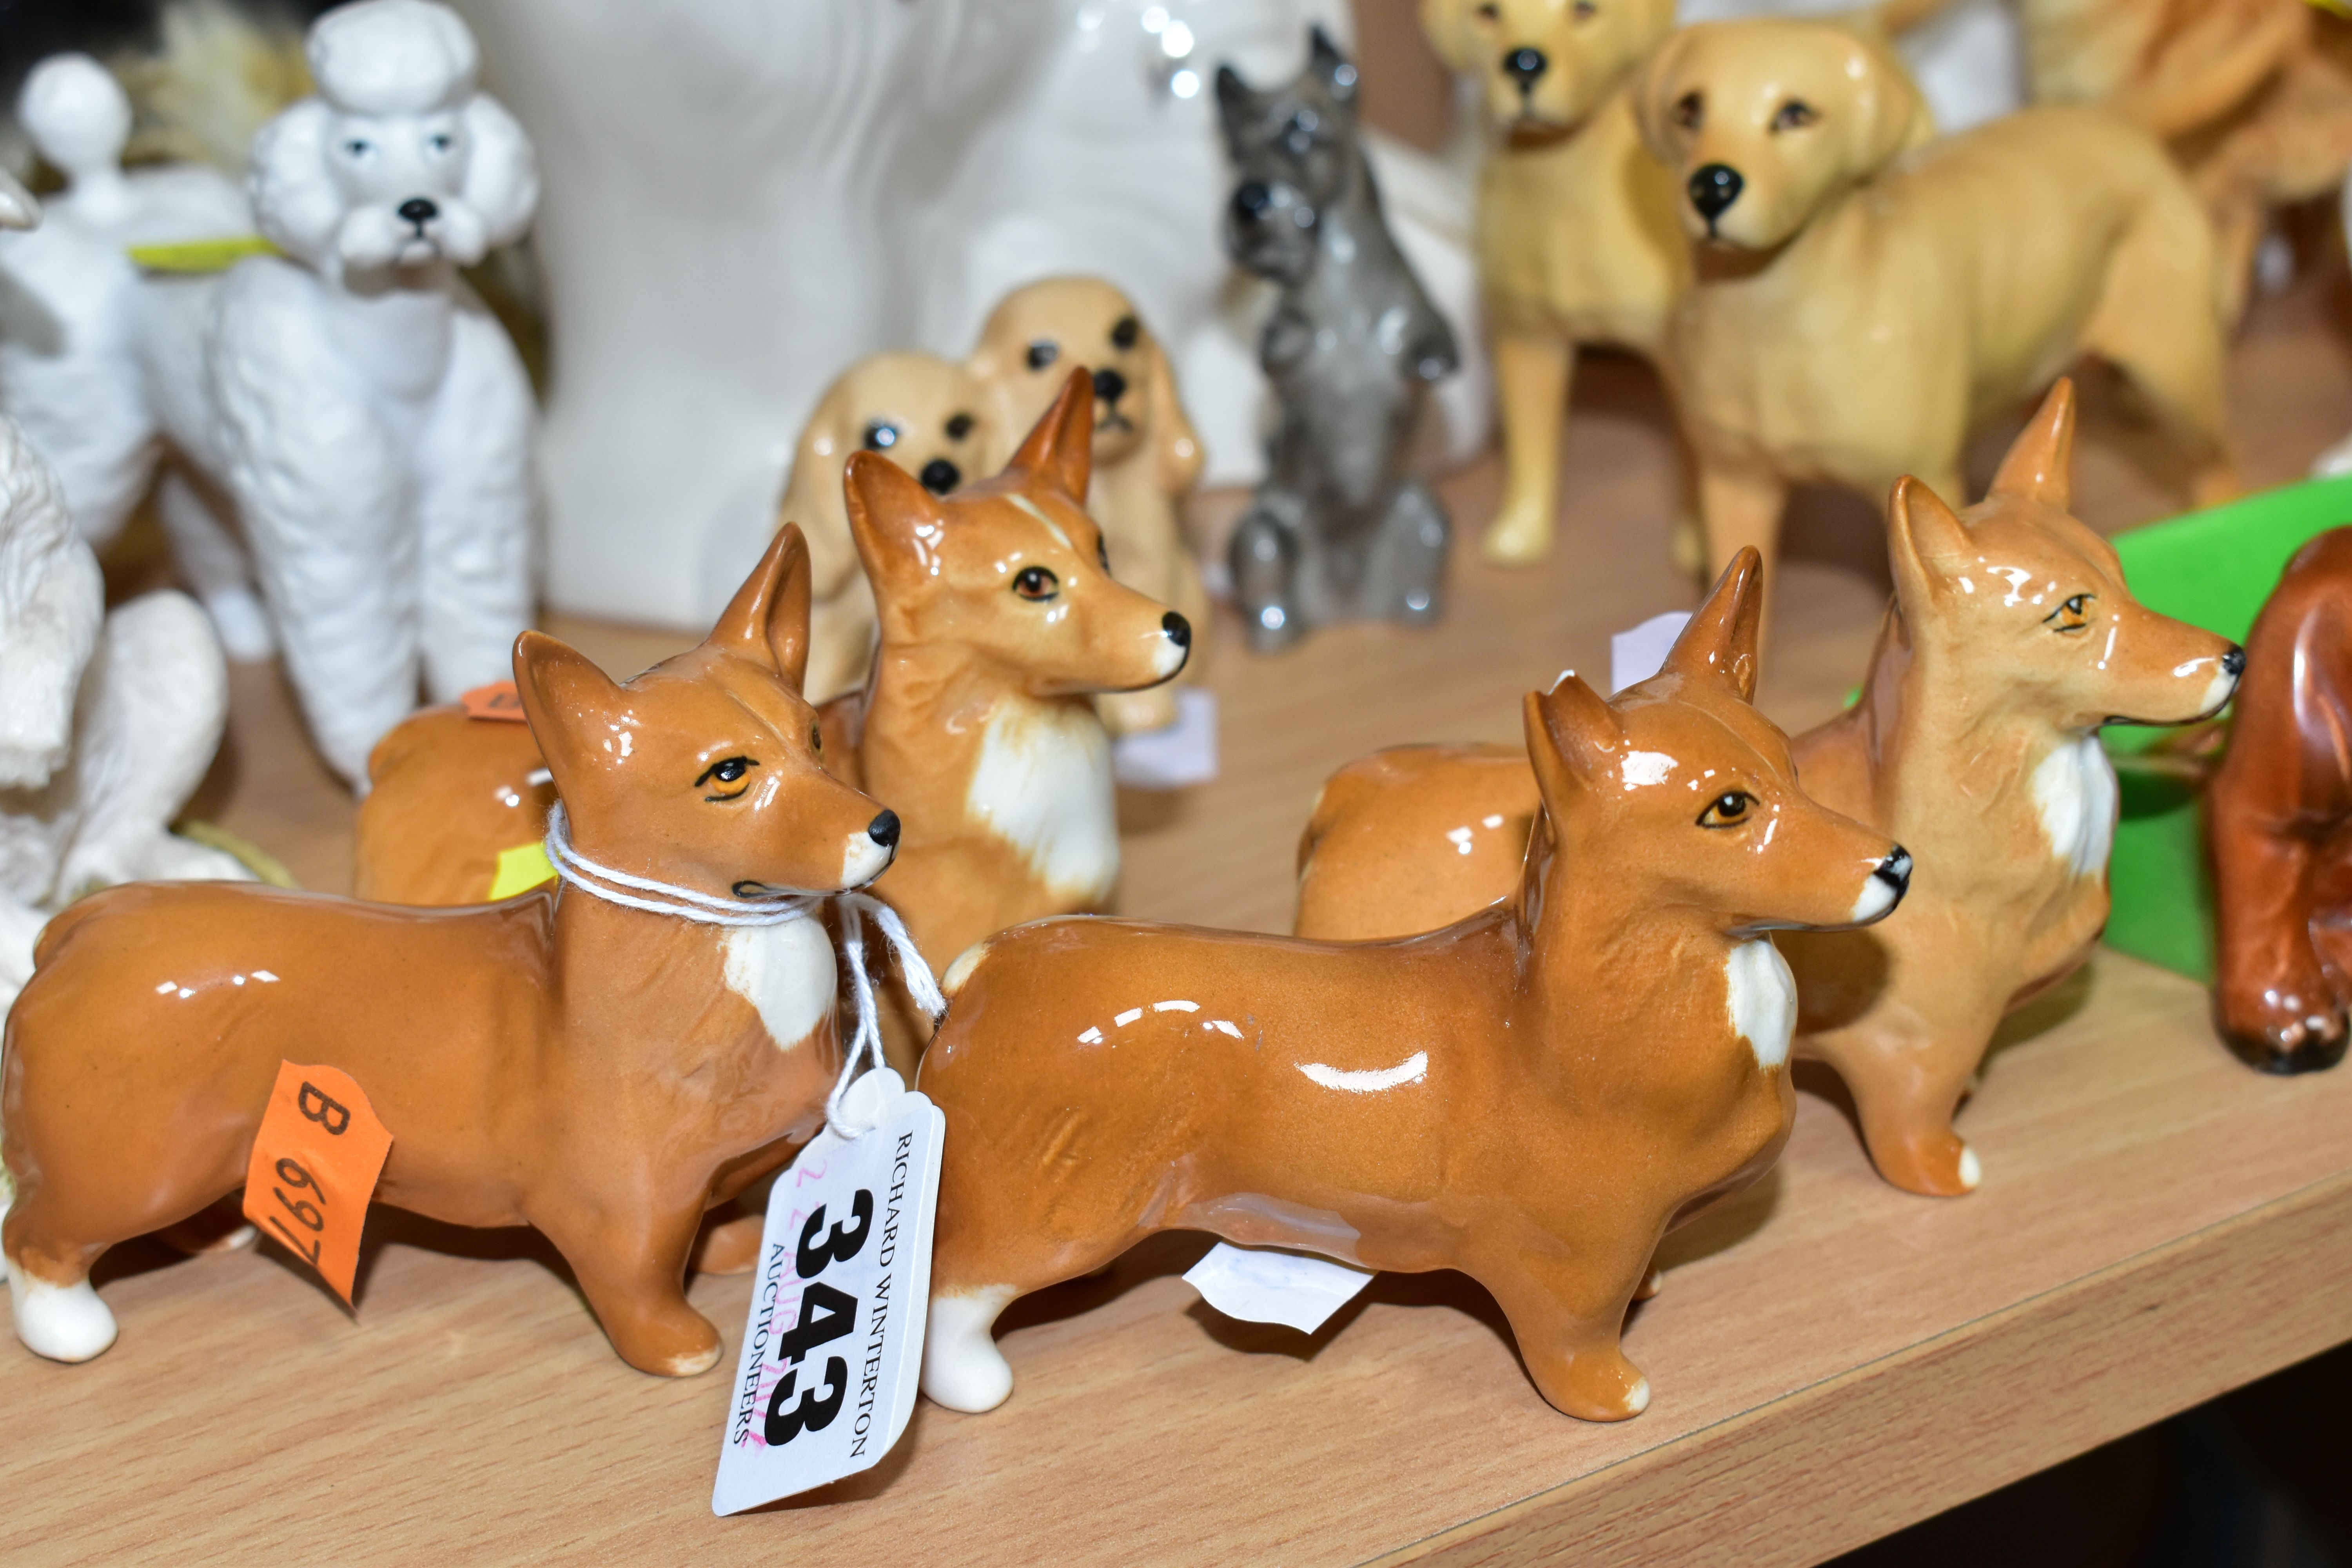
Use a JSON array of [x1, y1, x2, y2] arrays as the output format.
[[1635, 19, 2237, 621]]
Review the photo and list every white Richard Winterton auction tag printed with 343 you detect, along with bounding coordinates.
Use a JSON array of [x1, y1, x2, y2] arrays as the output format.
[[710, 1067, 948, 1514]]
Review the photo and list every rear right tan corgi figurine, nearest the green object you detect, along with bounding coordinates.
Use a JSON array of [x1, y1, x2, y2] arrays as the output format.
[[1298, 381, 2246, 1194]]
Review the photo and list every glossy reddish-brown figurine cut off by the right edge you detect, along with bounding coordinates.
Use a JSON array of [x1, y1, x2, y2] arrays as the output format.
[[2206, 529, 2352, 1072]]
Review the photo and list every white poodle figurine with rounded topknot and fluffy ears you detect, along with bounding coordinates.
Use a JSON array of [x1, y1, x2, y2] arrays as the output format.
[[11, 0, 539, 783]]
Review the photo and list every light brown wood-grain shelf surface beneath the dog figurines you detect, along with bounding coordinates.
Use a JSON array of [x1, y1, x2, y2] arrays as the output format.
[[14, 276, 2352, 1566]]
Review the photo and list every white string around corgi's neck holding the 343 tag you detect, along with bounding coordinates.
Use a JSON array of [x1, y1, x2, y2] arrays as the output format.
[[543, 802, 948, 1143]]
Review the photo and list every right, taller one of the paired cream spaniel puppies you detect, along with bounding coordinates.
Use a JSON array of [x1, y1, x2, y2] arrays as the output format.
[[964, 278, 1209, 736]]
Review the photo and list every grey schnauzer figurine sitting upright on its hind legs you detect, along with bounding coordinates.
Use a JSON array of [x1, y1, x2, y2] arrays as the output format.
[[1216, 28, 1458, 651]]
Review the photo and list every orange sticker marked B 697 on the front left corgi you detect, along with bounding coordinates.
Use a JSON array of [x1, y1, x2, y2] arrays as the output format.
[[245, 1063, 393, 1302]]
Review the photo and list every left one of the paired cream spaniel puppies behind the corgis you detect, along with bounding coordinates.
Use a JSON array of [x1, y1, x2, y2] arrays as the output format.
[[706, 353, 993, 703]]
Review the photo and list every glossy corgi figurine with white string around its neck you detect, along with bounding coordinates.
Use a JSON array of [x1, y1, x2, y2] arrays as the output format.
[[0, 526, 913, 1375]]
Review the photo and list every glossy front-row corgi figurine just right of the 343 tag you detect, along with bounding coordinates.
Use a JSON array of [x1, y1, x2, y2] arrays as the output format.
[[922, 552, 1910, 1420]]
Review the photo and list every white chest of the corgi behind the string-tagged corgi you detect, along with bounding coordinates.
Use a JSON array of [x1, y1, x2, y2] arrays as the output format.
[[964, 703, 1120, 903]]
